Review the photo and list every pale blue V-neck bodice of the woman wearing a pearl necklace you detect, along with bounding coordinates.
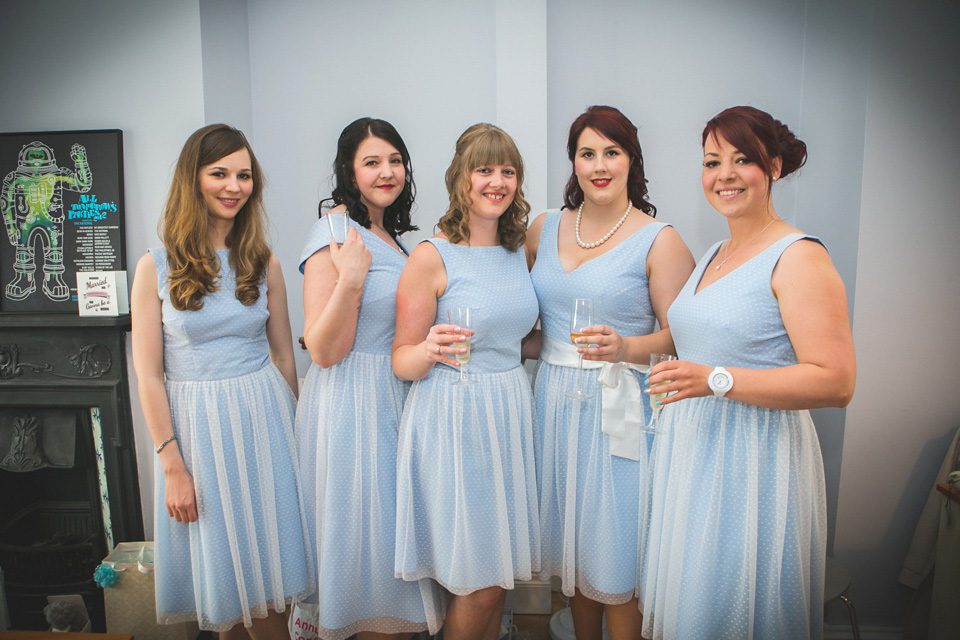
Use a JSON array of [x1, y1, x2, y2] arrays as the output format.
[[530, 211, 669, 342]]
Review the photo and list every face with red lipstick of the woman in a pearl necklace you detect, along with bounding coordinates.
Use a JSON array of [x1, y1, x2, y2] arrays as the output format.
[[573, 127, 630, 206]]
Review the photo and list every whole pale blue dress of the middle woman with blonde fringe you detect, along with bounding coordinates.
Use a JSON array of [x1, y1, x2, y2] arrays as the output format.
[[395, 238, 540, 595]]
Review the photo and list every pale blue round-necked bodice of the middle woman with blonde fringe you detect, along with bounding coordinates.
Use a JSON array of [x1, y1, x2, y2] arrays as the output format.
[[428, 238, 538, 373]]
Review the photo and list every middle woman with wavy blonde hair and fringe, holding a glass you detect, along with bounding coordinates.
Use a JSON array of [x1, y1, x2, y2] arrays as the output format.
[[393, 124, 540, 640]]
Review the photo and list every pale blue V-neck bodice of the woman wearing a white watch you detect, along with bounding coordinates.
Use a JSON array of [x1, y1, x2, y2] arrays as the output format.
[[667, 233, 820, 369]]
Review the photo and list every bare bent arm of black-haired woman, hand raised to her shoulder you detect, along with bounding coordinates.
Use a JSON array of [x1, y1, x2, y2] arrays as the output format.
[[303, 227, 373, 367]]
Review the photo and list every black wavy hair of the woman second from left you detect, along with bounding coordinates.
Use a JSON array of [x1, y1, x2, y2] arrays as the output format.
[[319, 118, 417, 238]]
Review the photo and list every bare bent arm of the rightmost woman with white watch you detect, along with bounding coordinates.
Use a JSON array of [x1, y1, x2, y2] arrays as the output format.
[[650, 241, 856, 409]]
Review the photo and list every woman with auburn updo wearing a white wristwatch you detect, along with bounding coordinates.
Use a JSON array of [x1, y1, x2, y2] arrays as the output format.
[[638, 107, 856, 640]]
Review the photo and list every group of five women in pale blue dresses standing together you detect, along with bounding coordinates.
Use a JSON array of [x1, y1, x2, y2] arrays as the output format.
[[131, 106, 856, 640]]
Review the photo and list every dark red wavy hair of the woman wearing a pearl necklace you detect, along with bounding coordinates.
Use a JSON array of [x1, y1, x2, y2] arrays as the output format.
[[563, 105, 657, 218]]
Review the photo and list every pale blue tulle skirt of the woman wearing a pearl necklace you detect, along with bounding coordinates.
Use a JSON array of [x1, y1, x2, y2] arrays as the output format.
[[535, 362, 649, 604]]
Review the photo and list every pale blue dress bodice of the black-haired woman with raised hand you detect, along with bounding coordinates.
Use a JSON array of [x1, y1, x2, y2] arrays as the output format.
[[300, 218, 407, 354]]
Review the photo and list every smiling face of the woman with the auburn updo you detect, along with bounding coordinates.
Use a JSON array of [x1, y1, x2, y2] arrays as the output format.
[[702, 136, 781, 216]]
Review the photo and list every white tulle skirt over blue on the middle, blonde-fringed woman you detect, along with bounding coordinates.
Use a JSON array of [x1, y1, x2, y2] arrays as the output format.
[[395, 365, 540, 595]]
